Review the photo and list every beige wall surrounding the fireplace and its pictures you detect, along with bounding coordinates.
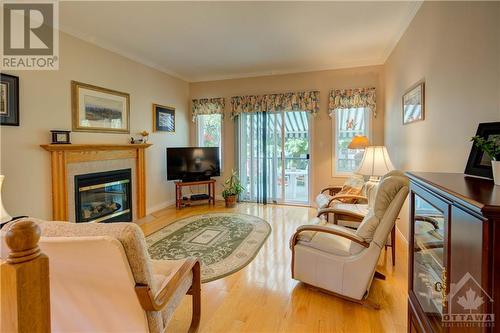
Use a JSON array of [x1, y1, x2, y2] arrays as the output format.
[[1, 33, 189, 218]]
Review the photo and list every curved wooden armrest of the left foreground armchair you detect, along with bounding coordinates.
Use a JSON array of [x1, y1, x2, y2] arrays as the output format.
[[135, 258, 200, 311]]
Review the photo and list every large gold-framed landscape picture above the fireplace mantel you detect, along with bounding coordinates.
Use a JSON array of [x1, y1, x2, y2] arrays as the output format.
[[71, 81, 130, 133]]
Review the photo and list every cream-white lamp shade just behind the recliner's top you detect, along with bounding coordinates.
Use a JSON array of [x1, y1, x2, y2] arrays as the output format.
[[356, 146, 394, 177]]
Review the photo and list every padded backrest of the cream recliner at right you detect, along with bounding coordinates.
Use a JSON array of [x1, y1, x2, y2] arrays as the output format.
[[351, 170, 409, 252]]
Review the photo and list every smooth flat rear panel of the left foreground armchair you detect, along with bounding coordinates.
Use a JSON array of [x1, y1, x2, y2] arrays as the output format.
[[40, 236, 149, 332]]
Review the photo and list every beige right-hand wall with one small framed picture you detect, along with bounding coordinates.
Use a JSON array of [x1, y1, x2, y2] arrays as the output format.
[[384, 2, 500, 236]]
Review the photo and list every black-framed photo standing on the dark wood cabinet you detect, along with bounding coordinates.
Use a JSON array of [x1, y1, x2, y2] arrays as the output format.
[[464, 122, 500, 179]]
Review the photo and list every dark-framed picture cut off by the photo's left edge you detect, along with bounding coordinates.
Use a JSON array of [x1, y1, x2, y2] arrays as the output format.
[[0, 74, 19, 126]]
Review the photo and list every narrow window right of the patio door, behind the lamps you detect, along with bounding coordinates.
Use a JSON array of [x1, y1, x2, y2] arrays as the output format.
[[333, 108, 370, 175]]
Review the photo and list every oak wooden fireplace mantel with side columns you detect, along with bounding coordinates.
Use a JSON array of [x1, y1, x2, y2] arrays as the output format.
[[40, 143, 151, 221]]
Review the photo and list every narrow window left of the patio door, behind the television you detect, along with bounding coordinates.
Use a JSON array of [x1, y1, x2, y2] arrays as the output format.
[[196, 113, 223, 168]]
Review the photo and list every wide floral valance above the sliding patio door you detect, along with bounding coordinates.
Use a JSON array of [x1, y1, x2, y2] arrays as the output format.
[[231, 91, 319, 118]]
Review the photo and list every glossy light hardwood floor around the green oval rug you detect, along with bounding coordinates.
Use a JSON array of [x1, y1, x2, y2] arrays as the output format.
[[141, 202, 408, 333]]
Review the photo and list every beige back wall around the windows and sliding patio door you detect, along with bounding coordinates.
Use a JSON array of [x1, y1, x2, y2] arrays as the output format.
[[189, 66, 384, 198]]
